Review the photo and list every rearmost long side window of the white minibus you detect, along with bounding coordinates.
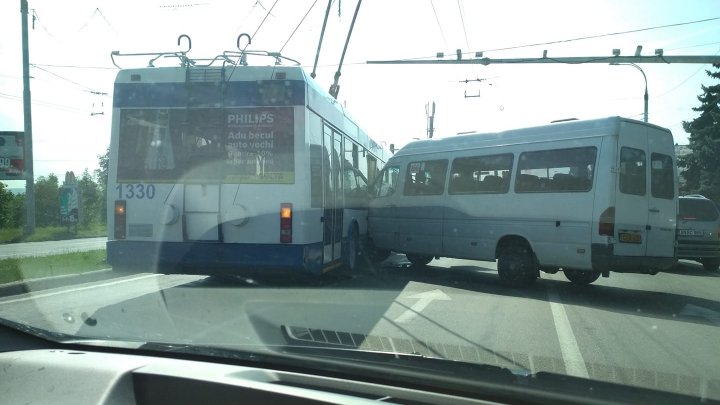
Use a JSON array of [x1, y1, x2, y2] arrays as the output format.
[[515, 146, 597, 193]]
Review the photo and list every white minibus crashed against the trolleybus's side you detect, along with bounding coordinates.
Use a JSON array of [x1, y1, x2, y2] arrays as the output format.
[[368, 117, 678, 286]]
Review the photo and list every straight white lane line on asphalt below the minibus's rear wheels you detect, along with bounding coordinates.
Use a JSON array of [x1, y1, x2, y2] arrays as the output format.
[[548, 286, 589, 378]]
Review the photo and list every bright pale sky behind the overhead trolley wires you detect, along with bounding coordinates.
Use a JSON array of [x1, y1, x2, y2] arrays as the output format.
[[0, 0, 720, 183]]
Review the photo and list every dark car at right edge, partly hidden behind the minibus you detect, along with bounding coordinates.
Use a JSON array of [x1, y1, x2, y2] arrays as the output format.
[[677, 194, 720, 271]]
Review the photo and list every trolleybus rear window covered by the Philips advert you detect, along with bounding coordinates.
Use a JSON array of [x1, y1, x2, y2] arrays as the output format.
[[118, 107, 295, 184]]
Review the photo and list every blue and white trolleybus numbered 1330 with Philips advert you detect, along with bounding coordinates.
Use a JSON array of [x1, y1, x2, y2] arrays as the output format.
[[107, 47, 390, 274]]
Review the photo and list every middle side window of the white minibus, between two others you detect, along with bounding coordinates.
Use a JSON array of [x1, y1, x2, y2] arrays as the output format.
[[448, 153, 513, 194]]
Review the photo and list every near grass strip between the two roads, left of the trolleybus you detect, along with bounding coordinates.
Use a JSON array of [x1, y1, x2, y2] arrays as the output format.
[[0, 249, 109, 284]]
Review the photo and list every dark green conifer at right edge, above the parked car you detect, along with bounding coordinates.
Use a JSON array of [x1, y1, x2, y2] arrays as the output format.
[[678, 64, 720, 201]]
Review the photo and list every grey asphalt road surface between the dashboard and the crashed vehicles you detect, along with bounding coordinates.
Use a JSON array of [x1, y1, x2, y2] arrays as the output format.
[[0, 255, 720, 399]]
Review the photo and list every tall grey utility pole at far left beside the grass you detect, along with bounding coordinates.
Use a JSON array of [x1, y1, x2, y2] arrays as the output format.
[[20, 0, 35, 235]]
